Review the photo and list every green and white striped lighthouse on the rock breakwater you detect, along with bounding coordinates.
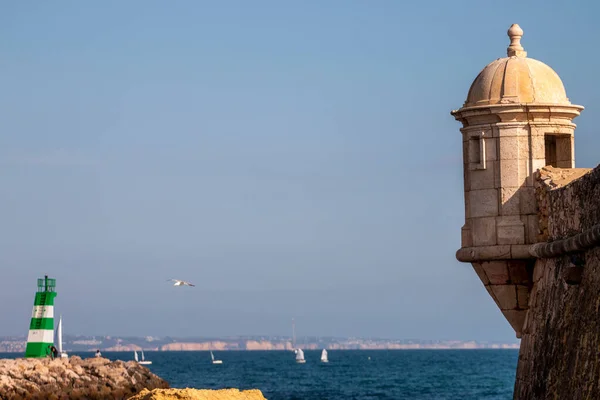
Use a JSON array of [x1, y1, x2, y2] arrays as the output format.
[[25, 275, 56, 358]]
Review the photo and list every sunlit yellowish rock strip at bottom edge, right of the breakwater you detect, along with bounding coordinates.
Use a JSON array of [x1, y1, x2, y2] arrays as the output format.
[[129, 389, 266, 400]]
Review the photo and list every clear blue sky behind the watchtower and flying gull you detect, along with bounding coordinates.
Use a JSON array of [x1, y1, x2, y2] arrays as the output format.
[[0, 0, 600, 341]]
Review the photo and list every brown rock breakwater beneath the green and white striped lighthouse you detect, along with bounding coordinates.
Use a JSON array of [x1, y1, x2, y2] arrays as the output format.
[[0, 356, 169, 400]]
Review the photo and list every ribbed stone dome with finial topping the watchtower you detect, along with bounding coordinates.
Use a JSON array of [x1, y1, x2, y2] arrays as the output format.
[[464, 24, 571, 107]]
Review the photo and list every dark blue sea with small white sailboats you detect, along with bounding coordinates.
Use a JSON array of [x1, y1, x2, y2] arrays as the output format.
[[0, 350, 518, 400]]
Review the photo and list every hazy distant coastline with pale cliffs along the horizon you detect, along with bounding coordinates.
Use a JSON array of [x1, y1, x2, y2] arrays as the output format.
[[0, 336, 520, 353]]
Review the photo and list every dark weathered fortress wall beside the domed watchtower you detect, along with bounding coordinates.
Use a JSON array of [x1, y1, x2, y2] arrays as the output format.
[[514, 167, 600, 400]]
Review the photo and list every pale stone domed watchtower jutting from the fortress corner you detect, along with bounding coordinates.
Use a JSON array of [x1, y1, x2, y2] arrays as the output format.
[[451, 24, 583, 337]]
